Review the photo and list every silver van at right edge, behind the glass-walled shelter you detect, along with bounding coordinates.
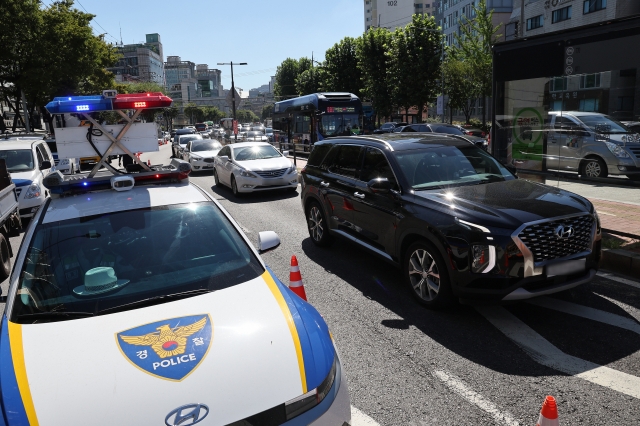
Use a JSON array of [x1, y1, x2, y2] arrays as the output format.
[[547, 111, 640, 181]]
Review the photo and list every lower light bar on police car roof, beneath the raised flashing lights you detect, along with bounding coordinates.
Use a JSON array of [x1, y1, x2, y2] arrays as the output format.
[[42, 158, 191, 196]]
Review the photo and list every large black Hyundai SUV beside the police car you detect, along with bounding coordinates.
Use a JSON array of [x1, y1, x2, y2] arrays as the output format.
[[302, 133, 601, 306]]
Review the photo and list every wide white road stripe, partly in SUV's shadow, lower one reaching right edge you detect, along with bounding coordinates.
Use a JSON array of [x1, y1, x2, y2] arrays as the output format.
[[476, 306, 640, 399]]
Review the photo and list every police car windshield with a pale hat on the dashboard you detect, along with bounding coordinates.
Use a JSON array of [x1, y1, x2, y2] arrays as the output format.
[[11, 203, 264, 324]]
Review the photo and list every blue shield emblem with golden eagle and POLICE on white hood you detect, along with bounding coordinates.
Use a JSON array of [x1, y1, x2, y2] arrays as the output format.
[[116, 314, 213, 382]]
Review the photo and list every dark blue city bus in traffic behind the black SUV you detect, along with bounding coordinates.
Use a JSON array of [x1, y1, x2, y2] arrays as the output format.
[[272, 92, 362, 151]]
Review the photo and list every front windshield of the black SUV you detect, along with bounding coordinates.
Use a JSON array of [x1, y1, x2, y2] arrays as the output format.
[[394, 145, 515, 190]]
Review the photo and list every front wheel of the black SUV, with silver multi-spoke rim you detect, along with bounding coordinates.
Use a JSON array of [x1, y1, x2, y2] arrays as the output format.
[[403, 241, 453, 308]]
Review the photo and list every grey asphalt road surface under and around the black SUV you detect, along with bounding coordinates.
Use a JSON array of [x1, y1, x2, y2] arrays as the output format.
[[3, 145, 640, 426]]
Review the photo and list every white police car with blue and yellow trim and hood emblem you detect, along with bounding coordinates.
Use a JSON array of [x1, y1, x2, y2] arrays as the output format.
[[0, 160, 350, 426]]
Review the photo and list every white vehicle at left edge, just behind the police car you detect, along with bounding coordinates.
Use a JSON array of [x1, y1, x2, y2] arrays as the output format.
[[0, 138, 53, 218]]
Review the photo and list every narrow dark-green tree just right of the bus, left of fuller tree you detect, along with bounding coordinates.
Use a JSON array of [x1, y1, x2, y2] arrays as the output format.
[[356, 28, 393, 125]]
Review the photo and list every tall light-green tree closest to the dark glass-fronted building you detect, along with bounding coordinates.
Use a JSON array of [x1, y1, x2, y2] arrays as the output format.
[[452, 0, 502, 126]]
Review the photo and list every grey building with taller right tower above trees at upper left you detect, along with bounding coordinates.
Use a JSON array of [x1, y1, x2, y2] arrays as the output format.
[[107, 33, 165, 85]]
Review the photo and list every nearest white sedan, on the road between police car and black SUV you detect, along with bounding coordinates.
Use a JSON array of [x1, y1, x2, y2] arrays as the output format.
[[213, 142, 298, 197]]
